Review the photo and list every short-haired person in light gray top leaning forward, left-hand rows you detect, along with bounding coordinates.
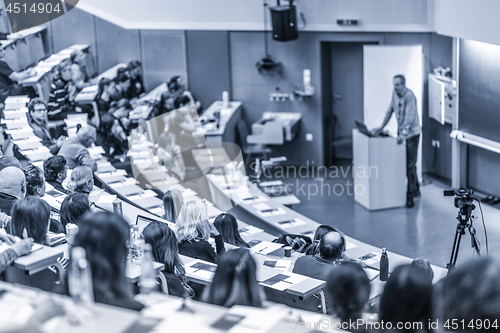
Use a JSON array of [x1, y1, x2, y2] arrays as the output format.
[[58, 125, 97, 171]]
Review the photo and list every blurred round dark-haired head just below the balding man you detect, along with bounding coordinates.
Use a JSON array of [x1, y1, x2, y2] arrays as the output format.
[[325, 262, 371, 332]]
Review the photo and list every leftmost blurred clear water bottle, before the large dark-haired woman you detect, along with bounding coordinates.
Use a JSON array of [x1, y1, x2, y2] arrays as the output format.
[[68, 247, 94, 306]]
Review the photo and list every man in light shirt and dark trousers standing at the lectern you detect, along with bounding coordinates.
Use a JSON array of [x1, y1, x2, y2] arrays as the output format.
[[373, 74, 422, 208]]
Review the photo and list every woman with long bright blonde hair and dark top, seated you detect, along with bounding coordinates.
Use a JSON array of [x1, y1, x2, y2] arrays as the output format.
[[175, 201, 225, 263]]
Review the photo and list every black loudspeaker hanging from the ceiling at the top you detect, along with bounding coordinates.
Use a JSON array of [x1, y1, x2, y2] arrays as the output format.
[[270, 5, 299, 42]]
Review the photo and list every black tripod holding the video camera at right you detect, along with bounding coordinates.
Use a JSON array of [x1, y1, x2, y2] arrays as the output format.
[[446, 201, 481, 274]]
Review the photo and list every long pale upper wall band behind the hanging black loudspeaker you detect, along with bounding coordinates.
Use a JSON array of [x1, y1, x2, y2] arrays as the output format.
[[77, 0, 435, 32]]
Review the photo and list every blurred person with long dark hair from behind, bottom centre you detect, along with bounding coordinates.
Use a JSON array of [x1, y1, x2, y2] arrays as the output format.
[[203, 249, 263, 308]]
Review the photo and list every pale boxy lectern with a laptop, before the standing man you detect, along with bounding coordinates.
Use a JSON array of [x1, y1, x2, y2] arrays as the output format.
[[352, 129, 406, 210]]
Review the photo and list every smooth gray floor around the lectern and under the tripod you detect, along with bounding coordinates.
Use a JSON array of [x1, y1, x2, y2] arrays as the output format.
[[278, 165, 500, 267]]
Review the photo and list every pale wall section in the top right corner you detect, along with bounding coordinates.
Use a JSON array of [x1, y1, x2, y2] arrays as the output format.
[[435, 0, 500, 45]]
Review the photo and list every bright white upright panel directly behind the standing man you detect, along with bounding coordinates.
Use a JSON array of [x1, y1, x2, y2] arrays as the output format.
[[363, 45, 424, 182]]
